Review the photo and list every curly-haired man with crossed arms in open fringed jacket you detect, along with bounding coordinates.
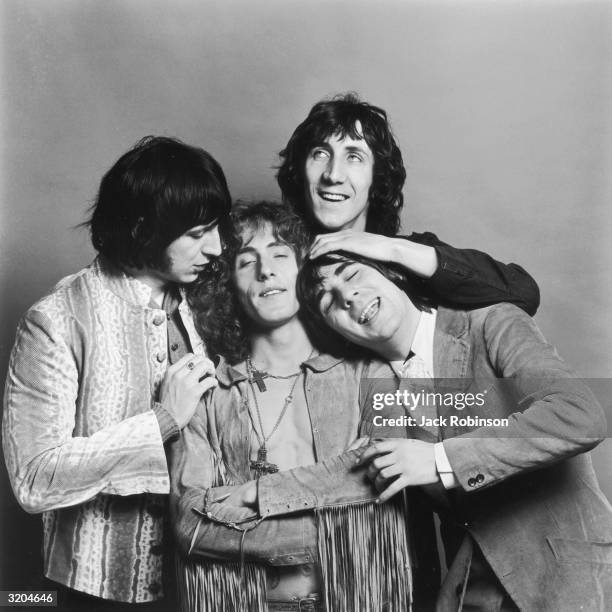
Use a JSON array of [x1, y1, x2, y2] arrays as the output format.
[[170, 202, 411, 612]]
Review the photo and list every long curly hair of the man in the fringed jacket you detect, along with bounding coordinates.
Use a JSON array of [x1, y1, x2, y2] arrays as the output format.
[[187, 200, 310, 364]]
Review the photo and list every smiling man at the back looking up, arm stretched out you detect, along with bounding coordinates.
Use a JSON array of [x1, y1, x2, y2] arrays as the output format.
[[277, 94, 540, 314]]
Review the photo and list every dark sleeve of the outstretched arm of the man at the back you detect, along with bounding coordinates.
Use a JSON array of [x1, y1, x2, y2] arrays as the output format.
[[402, 232, 540, 316]]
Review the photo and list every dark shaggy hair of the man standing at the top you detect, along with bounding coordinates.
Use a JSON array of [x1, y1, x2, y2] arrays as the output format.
[[276, 93, 406, 236]]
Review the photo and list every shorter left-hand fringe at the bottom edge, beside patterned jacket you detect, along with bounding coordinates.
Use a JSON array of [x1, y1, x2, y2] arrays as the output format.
[[176, 556, 267, 612]]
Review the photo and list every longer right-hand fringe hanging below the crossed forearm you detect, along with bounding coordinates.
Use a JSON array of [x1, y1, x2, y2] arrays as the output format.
[[317, 493, 412, 612]]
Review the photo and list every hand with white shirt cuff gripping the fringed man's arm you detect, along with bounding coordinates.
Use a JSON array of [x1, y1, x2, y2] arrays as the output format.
[[357, 438, 439, 502]]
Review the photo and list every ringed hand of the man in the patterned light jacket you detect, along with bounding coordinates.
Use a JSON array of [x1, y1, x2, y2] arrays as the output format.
[[159, 353, 218, 429]]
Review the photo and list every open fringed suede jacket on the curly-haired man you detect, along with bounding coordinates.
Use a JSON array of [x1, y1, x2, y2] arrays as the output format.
[[169, 355, 411, 612]]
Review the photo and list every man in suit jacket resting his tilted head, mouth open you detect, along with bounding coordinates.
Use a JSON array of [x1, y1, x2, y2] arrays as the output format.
[[288, 254, 612, 612]]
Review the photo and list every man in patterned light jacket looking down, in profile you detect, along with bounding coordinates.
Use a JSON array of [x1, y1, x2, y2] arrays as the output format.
[[3, 137, 230, 611]]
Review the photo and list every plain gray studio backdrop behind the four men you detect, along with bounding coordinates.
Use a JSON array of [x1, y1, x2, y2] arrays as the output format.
[[0, 0, 612, 587]]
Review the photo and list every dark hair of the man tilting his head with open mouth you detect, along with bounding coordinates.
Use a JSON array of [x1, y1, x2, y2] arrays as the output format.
[[297, 251, 437, 358]]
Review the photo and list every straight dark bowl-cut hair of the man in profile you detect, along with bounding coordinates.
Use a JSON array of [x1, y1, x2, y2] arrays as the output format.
[[89, 136, 231, 269]]
